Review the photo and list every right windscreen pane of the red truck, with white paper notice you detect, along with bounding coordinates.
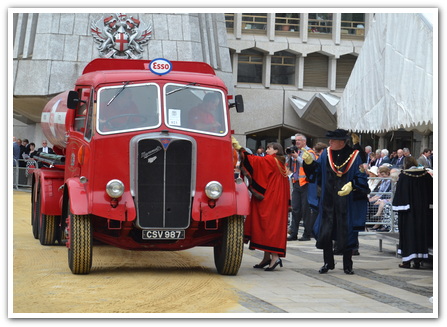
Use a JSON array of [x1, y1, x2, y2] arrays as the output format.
[[164, 84, 227, 135]]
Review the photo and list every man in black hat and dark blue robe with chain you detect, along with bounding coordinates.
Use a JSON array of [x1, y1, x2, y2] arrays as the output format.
[[303, 129, 370, 275]]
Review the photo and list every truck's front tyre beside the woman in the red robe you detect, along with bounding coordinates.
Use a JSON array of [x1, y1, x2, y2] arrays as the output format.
[[214, 216, 244, 275]]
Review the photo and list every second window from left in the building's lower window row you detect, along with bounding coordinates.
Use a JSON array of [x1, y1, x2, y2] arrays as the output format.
[[270, 51, 296, 85]]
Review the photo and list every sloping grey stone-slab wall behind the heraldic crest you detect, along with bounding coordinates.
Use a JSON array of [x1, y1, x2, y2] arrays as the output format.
[[13, 13, 232, 97]]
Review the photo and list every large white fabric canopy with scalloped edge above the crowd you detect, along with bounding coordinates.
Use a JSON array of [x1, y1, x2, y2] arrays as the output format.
[[337, 13, 434, 133]]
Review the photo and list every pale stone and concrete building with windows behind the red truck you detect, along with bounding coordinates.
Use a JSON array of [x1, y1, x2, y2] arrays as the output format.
[[10, 12, 428, 156]]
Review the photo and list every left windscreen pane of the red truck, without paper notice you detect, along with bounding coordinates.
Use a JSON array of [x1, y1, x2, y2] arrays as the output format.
[[96, 83, 161, 134]]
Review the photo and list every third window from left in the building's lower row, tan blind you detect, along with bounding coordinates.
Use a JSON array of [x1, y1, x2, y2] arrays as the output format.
[[303, 53, 329, 87]]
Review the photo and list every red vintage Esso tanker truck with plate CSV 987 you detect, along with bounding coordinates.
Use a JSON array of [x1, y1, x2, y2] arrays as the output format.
[[31, 59, 250, 275]]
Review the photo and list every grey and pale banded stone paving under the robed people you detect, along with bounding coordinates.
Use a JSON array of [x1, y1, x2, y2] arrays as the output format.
[[193, 234, 438, 318]]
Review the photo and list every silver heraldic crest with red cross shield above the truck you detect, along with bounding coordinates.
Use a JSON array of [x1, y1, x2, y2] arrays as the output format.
[[90, 13, 152, 59]]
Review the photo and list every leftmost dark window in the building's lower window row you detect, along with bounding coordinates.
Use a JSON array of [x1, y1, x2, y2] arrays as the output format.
[[237, 49, 264, 83]]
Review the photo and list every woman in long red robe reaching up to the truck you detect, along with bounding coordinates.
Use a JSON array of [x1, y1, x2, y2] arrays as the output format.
[[233, 138, 290, 271]]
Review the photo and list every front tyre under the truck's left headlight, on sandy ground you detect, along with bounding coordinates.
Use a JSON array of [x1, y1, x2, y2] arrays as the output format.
[[68, 214, 93, 274]]
